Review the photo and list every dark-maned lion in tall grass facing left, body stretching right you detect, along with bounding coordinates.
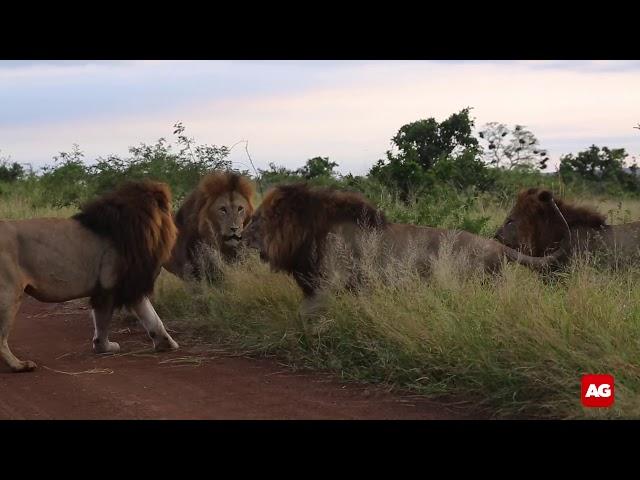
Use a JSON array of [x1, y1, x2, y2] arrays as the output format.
[[244, 183, 564, 310]]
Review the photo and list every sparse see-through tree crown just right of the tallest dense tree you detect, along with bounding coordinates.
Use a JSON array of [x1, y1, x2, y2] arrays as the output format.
[[479, 122, 549, 170]]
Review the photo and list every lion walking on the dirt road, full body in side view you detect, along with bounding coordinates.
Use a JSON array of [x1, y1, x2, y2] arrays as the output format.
[[0, 181, 178, 372]]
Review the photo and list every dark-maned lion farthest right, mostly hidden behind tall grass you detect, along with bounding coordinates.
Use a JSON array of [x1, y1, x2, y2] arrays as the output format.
[[495, 188, 640, 259]]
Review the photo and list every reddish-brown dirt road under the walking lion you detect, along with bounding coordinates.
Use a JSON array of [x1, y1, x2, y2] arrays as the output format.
[[0, 299, 478, 419]]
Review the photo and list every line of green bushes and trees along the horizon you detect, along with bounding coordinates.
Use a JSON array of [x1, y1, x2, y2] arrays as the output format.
[[0, 112, 640, 214]]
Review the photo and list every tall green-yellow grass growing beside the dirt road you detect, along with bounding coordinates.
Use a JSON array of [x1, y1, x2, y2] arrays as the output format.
[[5, 189, 640, 418]]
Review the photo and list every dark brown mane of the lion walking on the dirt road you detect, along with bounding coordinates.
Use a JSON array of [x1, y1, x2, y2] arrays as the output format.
[[73, 181, 177, 307]]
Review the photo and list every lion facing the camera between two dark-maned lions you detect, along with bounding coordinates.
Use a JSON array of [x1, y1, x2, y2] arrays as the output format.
[[164, 172, 255, 279]]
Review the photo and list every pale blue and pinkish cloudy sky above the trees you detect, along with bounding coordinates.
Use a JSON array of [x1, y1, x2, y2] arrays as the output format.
[[0, 60, 640, 173]]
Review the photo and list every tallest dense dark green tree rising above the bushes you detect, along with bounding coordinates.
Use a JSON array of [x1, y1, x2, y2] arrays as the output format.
[[369, 108, 479, 200]]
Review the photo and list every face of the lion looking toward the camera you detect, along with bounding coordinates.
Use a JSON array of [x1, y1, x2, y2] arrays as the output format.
[[205, 192, 251, 248]]
